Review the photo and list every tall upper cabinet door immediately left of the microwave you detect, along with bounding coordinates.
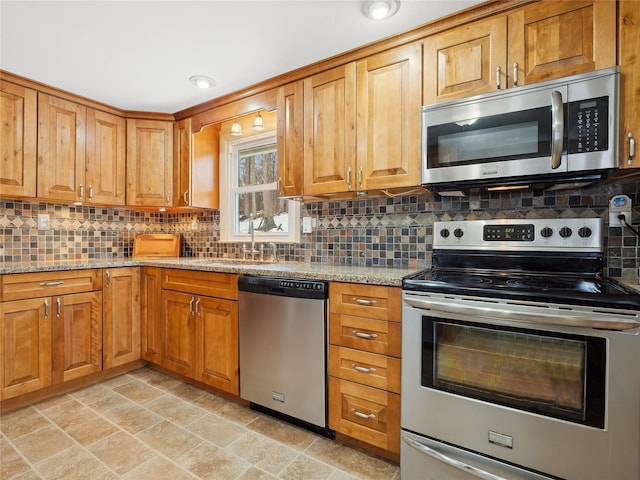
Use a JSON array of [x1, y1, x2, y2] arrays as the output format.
[[356, 43, 422, 190]]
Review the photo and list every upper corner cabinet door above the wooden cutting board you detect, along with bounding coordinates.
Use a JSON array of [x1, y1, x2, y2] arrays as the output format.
[[126, 120, 173, 207]]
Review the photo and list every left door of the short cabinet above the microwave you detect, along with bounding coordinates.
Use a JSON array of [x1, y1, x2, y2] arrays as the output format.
[[424, 16, 507, 105]]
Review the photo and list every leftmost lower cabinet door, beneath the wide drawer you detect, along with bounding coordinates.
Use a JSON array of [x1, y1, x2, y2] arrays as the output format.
[[0, 298, 52, 400]]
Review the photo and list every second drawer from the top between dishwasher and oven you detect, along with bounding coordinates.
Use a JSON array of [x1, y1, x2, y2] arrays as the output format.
[[329, 313, 402, 357]]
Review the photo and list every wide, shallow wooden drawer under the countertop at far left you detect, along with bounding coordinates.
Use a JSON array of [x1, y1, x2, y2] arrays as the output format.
[[0, 268, 102, 301]]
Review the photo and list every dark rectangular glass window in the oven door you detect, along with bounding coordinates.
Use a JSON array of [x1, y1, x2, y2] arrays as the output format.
[[422, 317, 606, 428]]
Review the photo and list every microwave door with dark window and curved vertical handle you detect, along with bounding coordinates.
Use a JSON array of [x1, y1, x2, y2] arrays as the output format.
[[423, 87, 567, 183]]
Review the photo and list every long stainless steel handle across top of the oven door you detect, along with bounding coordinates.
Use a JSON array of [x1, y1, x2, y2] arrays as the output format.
[[405, 298, 640, 330]]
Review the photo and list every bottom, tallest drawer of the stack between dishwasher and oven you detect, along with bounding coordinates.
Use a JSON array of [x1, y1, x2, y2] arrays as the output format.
[[329, 377, 400, 453]]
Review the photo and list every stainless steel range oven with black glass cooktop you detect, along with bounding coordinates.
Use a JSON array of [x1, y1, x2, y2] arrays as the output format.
[[401, 218, 640, 480]]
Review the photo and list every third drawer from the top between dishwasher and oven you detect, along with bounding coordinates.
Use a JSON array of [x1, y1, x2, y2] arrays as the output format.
[[329, 345, 400, 393]]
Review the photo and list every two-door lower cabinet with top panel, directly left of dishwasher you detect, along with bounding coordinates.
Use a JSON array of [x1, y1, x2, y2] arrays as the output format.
[[162, 269, 240, 395]]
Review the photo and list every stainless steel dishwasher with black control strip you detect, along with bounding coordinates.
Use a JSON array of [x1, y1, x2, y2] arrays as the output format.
[[238, 275, 334, 437]]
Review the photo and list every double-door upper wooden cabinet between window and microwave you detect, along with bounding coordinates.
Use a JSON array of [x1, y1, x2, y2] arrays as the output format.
[[304, 43, 422, 195]]
